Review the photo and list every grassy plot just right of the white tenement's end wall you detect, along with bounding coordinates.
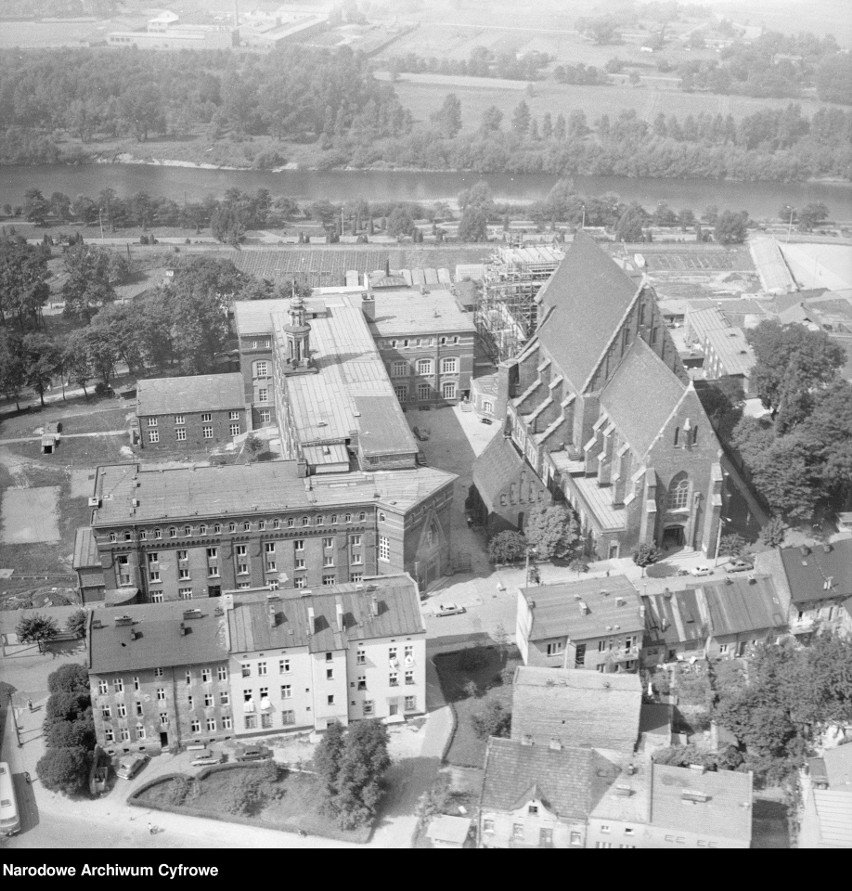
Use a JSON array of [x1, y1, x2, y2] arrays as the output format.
[[435, 647, 522, 767]]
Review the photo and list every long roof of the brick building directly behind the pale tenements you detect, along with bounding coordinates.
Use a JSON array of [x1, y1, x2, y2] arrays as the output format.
[[92, 461, 455, 528]]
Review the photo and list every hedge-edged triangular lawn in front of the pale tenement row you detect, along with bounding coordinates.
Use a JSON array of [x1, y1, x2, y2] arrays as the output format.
[[135, 765, 371, 843]]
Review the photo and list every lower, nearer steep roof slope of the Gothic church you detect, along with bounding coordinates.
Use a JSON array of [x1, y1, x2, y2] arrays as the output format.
[[601, 338, 687, 458]]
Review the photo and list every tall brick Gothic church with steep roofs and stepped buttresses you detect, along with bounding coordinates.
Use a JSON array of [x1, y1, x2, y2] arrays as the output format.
[[474, 232, 723, 557]]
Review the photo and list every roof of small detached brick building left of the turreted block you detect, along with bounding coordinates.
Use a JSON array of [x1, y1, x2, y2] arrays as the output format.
[[136, 372, 246, 417]]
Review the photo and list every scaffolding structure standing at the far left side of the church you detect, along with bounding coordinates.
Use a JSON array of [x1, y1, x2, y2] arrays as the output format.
[[474, 245, 565, 362]]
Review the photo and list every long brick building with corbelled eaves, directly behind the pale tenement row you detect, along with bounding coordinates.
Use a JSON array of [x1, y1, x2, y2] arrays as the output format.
[[81, 461, 455, 603]]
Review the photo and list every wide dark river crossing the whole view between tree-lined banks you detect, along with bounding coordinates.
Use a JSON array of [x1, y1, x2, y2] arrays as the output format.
[[0, 164, 852, 220]]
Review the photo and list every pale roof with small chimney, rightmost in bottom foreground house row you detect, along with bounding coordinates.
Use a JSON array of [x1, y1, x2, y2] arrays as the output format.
[[651, 764, 752, 847]]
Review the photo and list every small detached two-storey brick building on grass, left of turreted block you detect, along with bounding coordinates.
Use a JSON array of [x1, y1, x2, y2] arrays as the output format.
[[136, 373, 246, 449]]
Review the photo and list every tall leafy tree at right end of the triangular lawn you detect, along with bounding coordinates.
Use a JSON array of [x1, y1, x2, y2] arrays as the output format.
[[331, 721, 391, 829]]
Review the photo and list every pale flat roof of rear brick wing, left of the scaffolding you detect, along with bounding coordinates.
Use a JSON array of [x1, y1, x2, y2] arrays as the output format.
[[370, 287, 476, 337]]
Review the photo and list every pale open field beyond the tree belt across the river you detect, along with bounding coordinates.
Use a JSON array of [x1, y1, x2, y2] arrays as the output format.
[[394, 74, 822, 130]]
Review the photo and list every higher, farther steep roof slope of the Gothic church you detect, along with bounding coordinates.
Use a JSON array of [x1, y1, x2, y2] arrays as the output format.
[[535, 232, 639, 392]]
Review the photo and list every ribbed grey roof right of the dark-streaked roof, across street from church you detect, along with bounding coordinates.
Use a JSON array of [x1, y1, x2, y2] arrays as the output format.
[[700, 576, 786, 637]]
